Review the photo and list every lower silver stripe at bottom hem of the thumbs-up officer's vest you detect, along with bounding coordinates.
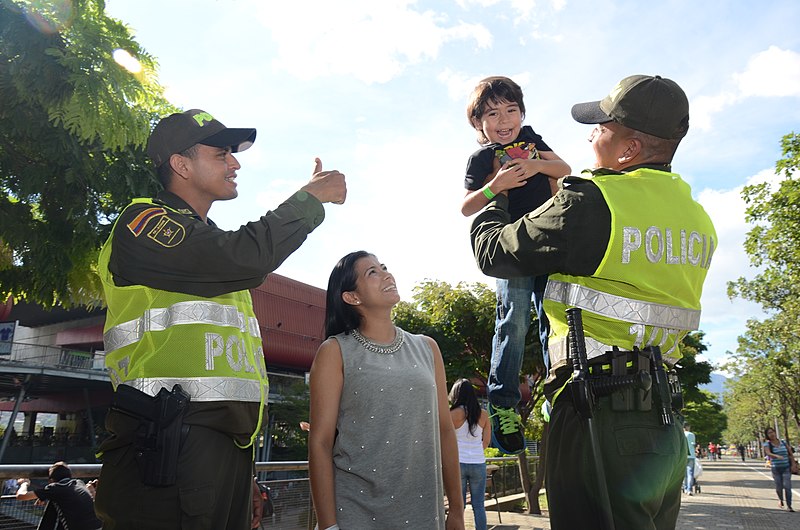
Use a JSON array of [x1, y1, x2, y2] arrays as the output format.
[[122, 377, 266, 403]]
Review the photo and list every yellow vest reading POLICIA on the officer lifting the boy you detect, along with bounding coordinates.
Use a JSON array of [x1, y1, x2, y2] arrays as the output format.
[[544, 168, 717, 368]]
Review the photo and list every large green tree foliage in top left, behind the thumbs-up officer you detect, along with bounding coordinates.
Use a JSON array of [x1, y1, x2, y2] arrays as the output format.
[[0, 0, 175, 306]]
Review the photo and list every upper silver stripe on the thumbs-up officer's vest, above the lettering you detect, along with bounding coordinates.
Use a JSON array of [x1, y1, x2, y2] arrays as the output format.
[[103, 301, 261, 352]]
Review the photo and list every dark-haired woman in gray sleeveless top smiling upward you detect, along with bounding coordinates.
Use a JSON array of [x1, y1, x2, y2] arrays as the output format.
[[308, 251, 464, 530]]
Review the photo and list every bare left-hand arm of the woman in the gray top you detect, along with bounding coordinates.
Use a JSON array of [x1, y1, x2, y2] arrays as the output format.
[[308, 339, 344, 528]]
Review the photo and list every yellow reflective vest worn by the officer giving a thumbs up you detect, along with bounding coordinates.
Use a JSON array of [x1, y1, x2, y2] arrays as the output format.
[[98, 199, 269, 444]]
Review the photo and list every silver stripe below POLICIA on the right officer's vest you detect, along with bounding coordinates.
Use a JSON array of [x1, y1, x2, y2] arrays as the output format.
[[544, 280, 700, 328]]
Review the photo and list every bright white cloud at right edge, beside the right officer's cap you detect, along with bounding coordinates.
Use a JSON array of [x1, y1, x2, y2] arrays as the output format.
[[691, 46, 800, 130]]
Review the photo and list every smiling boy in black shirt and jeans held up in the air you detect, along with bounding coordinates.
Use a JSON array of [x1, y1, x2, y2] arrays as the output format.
[[461, 76, 570, 454]]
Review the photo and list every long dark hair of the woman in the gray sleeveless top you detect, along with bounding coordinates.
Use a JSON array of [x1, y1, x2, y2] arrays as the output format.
[[325, 250, 373, 337]]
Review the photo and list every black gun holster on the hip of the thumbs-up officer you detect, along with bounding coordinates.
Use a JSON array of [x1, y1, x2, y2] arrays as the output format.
[[111, 384, 191, 486]]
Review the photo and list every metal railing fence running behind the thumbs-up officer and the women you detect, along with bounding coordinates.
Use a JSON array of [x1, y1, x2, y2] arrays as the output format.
[[0, 457, 538, 530]]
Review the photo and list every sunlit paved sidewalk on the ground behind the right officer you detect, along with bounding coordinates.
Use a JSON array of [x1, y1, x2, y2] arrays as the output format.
[[464, 456, 800, 530]]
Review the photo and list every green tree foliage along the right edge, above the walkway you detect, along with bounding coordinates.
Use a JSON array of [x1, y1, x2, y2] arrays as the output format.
[[728, 133, 800, 442]]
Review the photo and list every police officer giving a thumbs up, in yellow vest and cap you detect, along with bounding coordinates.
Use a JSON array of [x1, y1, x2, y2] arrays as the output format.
[[96, 109, 347, 530]]
